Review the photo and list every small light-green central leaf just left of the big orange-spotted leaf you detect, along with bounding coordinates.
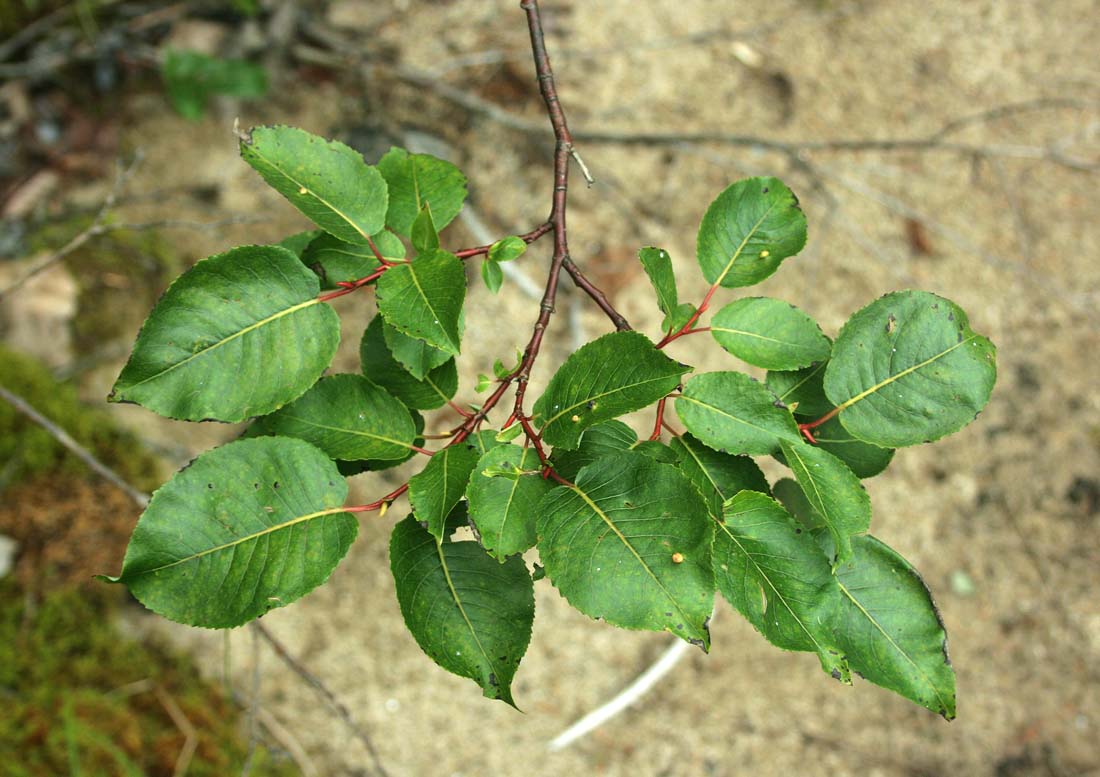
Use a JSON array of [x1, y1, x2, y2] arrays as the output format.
[[466, 445, 553, 561]]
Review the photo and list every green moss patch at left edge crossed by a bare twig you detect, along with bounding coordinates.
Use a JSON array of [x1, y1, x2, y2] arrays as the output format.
[[0, 346, 161, 491]]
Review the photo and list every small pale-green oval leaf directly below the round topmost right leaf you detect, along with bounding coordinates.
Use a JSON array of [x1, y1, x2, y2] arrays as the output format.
[[711, 297, 831, 370]]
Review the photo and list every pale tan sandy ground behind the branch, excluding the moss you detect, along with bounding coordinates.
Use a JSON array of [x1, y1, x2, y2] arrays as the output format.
[[17, 0, 1100, 777]]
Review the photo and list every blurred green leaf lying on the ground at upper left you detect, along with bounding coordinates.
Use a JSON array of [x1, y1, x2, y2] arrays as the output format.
[[161, 48, 267, 121]]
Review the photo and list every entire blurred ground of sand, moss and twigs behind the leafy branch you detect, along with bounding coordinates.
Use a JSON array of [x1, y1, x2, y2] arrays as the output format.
[[0, 0, 1100, 777]]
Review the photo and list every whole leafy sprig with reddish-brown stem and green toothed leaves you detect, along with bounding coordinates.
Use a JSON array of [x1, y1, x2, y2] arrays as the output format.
[[108, 0, 996, 719]]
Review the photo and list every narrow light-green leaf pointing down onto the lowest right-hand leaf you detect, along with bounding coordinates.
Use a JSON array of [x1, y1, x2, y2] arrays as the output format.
[[779, 440, 871, 562]]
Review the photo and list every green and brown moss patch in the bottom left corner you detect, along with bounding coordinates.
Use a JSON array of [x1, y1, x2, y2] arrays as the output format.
[[0, 580, 298, 777]]
